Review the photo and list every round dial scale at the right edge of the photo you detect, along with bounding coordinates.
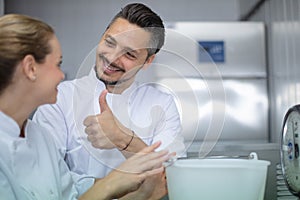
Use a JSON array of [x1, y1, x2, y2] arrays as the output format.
[[280, 105, 300, 197]]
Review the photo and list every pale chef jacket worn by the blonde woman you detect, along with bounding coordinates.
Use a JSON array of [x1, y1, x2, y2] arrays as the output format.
[[0, 111, 94, 200]]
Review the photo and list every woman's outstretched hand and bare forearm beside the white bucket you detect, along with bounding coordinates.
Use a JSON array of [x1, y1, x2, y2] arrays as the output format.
[[80, 142, 175, 200]]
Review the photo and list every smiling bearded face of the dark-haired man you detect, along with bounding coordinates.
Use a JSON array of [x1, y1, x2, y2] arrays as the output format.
[[96, 18, 154, 85]]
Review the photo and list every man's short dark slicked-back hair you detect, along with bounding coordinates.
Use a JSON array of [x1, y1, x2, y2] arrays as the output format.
[[107, 3, 165, 56]]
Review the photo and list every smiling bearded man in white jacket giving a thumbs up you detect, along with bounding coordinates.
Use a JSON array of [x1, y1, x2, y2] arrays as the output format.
[[34, 4, 184, 199]]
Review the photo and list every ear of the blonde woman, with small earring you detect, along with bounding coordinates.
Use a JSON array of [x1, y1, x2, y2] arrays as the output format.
[[21, 55, 37, 81]]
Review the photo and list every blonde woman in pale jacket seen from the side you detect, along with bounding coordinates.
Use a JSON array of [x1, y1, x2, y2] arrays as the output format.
[[0, 14, 172, 200]]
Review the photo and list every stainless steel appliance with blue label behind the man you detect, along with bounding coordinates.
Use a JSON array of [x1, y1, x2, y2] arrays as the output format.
[[150, 22, 269, 157]]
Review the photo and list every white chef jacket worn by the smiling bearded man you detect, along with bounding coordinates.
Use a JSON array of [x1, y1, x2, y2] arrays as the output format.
[[33, 70, 185, 178]]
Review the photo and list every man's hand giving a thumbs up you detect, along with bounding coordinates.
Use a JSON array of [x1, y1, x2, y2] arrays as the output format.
[[83, 90, 131, 149]]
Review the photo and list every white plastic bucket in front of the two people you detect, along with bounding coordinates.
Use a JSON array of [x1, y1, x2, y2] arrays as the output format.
[[166, 153, 270, 200]]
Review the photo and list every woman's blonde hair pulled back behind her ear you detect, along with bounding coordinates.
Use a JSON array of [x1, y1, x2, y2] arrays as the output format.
[[0, 14, 54, 94]]
